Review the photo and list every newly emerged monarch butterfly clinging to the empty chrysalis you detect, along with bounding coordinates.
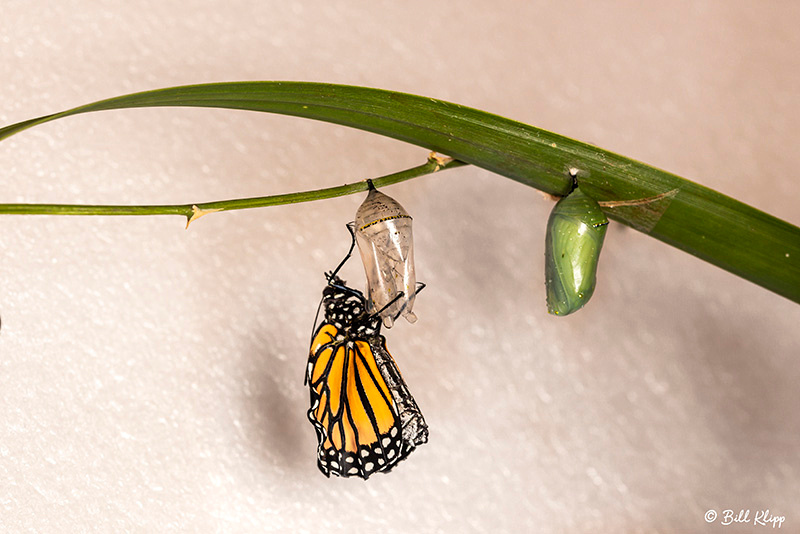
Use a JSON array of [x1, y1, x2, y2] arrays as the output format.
[[305, 226, 428, 480]]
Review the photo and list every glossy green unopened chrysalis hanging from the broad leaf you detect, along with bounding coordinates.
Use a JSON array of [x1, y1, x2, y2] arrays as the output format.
[[544, 188, 608, 315]]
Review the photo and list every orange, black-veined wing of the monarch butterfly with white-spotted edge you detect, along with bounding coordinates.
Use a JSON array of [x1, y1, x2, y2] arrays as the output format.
[[306, 322, 415, 479]]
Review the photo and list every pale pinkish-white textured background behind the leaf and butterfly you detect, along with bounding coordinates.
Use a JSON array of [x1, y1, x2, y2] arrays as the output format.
[[0, 0, 800, 533]]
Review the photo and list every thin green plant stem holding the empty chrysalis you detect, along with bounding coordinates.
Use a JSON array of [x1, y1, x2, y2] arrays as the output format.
[[0, 157, 466, 226]]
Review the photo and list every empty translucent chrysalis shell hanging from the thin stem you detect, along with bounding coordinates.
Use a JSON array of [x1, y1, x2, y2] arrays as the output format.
[[355, 180, 417, 328]]
